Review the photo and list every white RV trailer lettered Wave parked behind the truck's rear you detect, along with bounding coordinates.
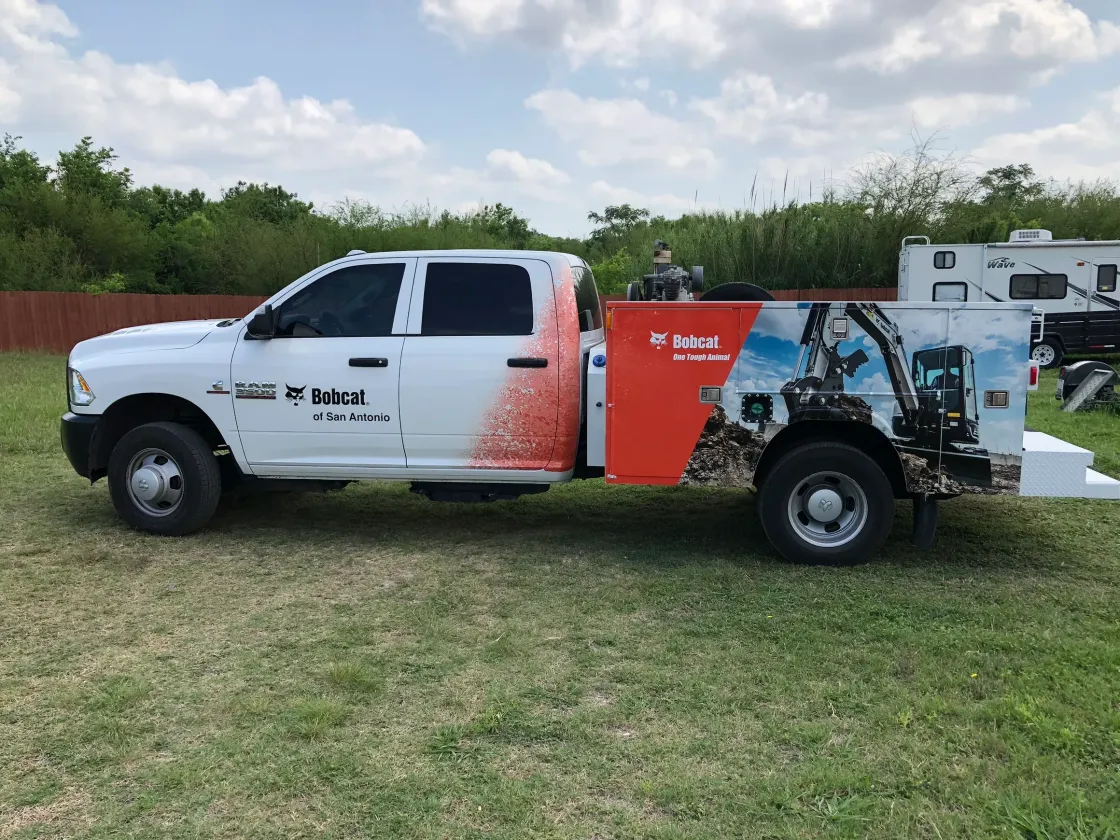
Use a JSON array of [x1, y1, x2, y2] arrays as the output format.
[[898, 231, 1120, 367]]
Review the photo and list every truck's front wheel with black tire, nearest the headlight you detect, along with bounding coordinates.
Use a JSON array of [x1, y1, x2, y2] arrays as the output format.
[[109, 422, 222, 536]]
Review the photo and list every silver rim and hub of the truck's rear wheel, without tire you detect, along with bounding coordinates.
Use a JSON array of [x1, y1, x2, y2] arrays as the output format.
[[787, 472, 868, 548]]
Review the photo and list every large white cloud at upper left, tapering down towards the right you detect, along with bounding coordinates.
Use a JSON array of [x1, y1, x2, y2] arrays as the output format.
[[0, 0, 427, 185]]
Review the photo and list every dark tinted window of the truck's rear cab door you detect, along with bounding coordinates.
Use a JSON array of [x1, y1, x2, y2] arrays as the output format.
[[420, 262, 533, 335]]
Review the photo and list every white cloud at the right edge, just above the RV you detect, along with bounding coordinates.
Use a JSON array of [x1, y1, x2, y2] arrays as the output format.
[[972, 87, 1120, 180]]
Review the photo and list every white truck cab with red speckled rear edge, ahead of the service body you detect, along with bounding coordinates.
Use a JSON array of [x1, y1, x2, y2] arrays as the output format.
[[63, 251, 604, 531]]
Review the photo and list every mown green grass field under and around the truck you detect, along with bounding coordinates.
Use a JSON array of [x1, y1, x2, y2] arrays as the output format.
[[0, 356, 1120, 840]]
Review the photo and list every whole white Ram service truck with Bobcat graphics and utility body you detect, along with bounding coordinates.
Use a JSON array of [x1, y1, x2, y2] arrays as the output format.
[[62, 251, 1120, 563]]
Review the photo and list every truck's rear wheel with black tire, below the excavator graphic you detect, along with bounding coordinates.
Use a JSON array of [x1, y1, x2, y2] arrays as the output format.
[[758, 441, 895, 566]]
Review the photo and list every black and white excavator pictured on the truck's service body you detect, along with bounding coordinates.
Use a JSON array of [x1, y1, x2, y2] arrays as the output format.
[[781, 302, 991, 486]]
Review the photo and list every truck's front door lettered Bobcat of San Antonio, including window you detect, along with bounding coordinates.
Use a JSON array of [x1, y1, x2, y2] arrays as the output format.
[[231, 259, 417, 476]]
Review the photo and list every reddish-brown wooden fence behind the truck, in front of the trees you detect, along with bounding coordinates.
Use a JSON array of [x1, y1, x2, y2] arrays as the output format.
[[0, 289, 897, 353]]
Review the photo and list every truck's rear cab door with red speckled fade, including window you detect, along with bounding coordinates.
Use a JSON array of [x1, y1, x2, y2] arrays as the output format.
[[400, 256, 559, 473]]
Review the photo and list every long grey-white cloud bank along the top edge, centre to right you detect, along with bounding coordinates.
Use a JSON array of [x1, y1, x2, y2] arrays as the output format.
[[421, 0, 1120, 84]]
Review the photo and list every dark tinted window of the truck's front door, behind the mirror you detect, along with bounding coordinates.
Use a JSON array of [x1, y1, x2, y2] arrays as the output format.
[[277, 262, 404, 338]]
